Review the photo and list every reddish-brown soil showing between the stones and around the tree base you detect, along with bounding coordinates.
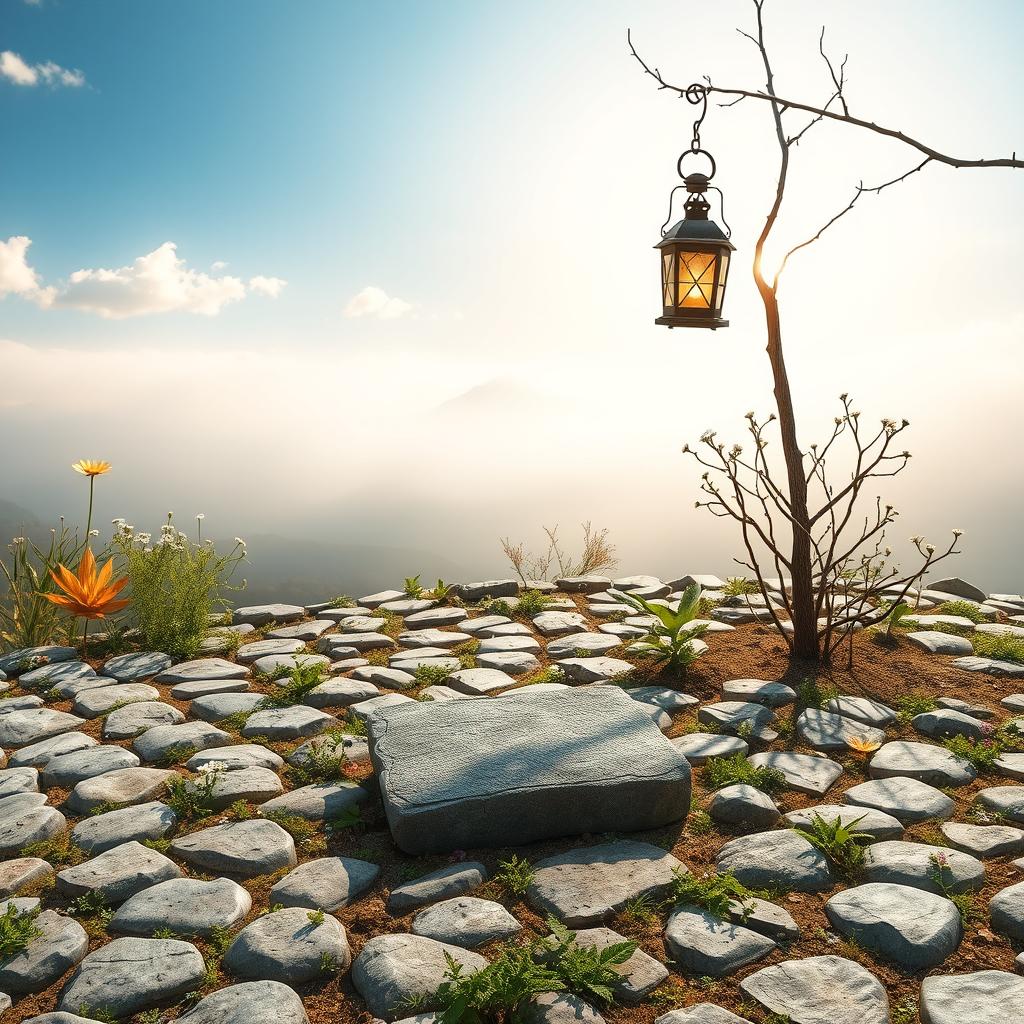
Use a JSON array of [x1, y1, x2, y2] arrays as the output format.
[[0, 600, 1022, 1024]]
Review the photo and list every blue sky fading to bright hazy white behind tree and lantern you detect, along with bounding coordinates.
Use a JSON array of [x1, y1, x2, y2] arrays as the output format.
[[0, 0, 1024, 587]]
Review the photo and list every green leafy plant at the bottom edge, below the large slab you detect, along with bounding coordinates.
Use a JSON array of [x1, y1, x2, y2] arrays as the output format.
[[435, 918, 637, 1024]]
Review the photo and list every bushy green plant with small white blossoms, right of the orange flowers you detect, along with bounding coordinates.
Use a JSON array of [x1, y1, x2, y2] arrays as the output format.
[[113, 513, 246, 657]]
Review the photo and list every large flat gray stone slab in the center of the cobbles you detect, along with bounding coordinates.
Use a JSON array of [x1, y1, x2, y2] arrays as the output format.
[[368, 687, 690, 853]]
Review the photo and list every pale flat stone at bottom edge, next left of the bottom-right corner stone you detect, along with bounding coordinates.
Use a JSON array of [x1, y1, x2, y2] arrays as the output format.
[[739, 956, 889, 1024]]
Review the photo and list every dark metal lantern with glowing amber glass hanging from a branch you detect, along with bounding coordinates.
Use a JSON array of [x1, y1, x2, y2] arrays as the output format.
[[654, 85, 736, 331]]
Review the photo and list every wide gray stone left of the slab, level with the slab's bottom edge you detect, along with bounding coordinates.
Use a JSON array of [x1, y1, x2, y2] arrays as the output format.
[[171, 819, 297, 879]]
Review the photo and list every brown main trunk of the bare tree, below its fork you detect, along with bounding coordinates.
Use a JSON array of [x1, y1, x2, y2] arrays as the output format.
[[756, 274, 820, 660]]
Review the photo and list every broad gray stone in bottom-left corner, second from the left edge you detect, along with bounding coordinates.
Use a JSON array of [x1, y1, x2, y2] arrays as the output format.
[[57, 938, 206, 1020]]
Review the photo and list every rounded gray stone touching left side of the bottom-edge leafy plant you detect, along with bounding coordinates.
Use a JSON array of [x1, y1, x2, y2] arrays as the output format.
[[351, 935, 487, 1021]]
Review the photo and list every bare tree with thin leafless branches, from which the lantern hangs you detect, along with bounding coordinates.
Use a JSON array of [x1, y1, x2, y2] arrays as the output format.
[[627, 0, 1024, 659]]
